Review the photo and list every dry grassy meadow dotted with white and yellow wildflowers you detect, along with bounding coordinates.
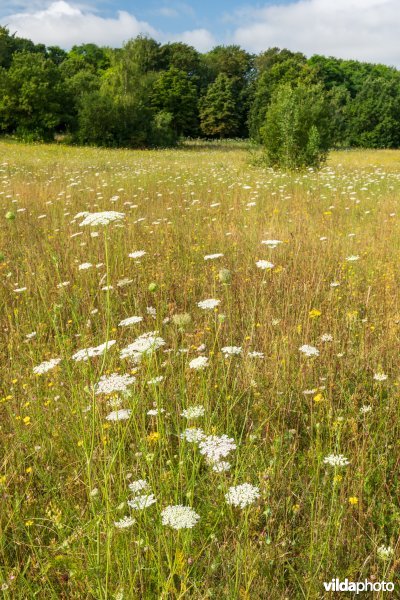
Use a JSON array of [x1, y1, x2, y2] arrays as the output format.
[[0, 142, 400, 600]]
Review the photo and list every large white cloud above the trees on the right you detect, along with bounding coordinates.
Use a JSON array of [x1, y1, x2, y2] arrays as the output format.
[[232, 0, 400, 66]]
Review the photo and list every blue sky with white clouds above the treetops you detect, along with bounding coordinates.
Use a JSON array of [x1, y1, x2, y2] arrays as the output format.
[[0, 0, 400, 66]]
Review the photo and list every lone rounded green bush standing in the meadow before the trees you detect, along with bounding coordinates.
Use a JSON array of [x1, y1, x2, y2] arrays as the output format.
[[261, 84, 331, 169]]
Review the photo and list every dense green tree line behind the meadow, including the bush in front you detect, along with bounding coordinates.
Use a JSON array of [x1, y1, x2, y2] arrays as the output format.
[[0, 27, 400, 156]]
